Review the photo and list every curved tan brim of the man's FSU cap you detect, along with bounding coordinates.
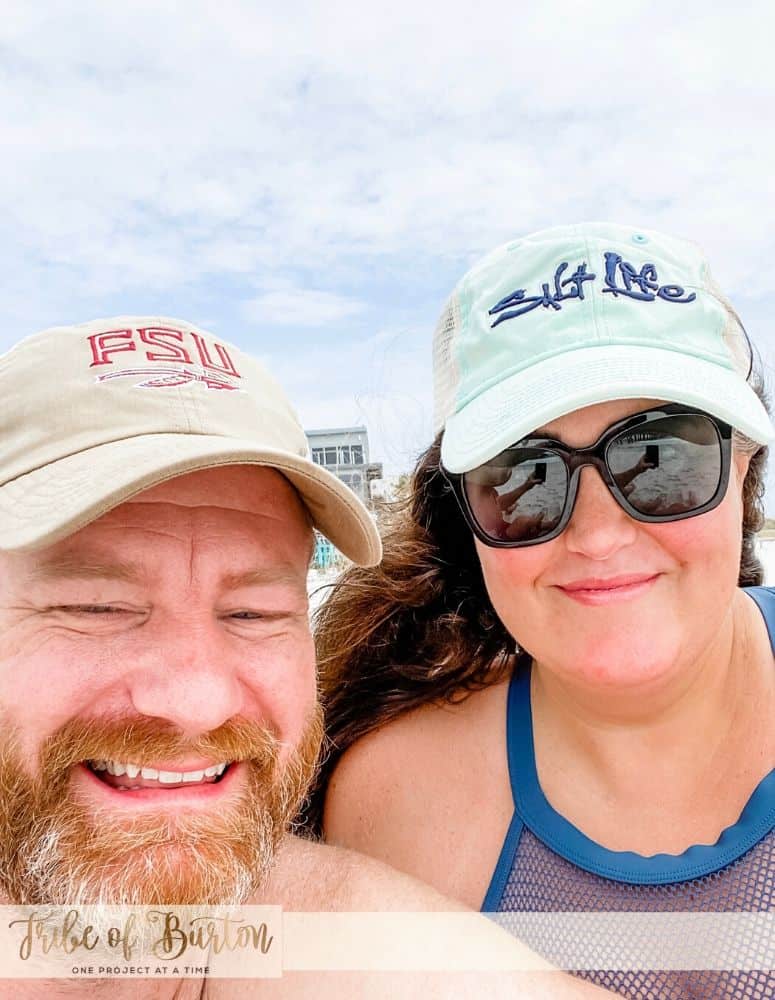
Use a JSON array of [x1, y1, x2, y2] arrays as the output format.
[[0, 434, 382, 566]]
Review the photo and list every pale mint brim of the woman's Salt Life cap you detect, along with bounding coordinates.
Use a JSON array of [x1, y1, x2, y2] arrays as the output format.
[[441, 345, 775, 472]]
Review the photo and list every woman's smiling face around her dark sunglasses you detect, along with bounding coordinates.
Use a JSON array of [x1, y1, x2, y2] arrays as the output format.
[[476, 399, 748, 689]]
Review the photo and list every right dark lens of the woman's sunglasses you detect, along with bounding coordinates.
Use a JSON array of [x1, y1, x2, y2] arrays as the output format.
[[606, 413, 721, 517]]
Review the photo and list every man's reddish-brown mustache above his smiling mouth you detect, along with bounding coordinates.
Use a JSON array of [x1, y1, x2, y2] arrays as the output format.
[[39, 716, 281, 780]]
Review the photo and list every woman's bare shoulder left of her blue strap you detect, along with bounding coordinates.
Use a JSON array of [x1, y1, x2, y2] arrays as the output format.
[[323, 681, 513, 906]]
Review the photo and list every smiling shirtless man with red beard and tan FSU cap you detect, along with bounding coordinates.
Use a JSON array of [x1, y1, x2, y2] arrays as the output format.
[[0, 317, 608, 997]]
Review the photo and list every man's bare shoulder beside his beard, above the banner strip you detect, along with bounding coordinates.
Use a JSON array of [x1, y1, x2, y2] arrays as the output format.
[[255, 835, 463, 911]]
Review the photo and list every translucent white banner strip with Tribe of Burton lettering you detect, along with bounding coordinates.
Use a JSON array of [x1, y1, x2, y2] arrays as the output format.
[[0, 906, 775, 979]]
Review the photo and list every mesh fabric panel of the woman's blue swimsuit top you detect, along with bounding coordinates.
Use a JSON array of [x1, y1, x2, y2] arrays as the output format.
[[498, 828, 775, 1000]]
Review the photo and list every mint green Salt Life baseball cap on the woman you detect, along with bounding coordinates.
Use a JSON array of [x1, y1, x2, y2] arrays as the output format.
[[433, 222, 775, 472]]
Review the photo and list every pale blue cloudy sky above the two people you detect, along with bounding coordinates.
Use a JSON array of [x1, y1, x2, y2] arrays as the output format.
[[0, 0, 775, 510]]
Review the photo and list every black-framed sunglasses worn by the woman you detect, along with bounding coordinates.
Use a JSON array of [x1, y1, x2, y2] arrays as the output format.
[[441, 403, 732, 548]]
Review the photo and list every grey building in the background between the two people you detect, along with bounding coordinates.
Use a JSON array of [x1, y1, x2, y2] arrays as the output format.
[[305, 427, 382, 570]]
